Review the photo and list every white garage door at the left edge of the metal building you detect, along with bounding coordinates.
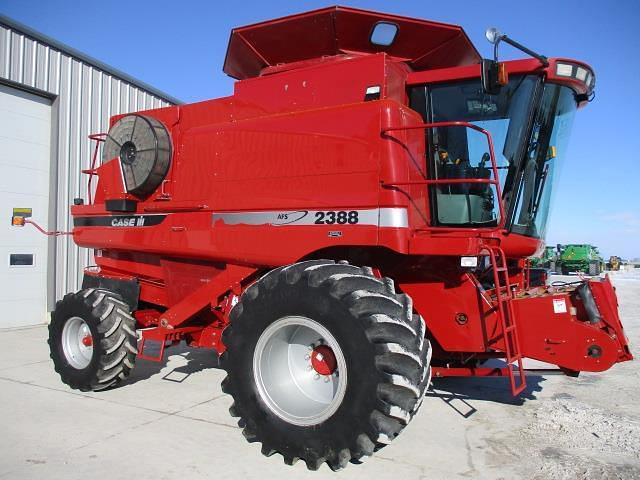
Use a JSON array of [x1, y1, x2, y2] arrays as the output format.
[[0, 84, 51, 328]]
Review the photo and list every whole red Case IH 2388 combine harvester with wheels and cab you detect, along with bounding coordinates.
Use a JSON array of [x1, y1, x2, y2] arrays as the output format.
[[22, 7, 631, 469]]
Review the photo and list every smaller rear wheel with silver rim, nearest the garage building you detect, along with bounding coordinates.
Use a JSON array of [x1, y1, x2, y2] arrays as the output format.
[[49, 288, 137, 391]]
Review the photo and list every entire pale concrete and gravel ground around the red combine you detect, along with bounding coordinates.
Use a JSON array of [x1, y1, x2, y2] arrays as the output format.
[[0, 270, 640, 480]]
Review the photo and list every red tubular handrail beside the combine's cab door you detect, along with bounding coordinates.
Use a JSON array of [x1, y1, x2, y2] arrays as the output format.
[[381, 122, 506, 230]]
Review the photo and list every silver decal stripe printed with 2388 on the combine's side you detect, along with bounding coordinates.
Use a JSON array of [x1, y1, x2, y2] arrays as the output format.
[[212, 207, 409, 228]]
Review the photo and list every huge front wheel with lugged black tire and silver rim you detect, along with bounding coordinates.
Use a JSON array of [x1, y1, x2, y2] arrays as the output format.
[[221, 260, 431, 470]]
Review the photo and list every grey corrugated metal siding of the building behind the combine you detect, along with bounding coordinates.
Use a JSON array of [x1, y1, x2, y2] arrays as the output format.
[[0, 24, 172, 304]]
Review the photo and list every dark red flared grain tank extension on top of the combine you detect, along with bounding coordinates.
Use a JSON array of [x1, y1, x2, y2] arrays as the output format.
[[223, 7, 481, 80]]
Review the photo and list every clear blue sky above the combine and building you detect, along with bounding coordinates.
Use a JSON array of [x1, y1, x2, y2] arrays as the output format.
[[0, 0, 640, 258]]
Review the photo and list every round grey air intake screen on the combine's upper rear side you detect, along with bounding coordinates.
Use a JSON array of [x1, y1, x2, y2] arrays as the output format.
[[102, 115, 171, 196]]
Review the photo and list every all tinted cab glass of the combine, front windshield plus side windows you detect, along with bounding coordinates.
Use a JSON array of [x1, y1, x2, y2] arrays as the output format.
[[410, 75, 576, 237]]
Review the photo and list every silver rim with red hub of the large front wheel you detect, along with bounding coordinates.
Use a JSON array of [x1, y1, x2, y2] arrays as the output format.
[[253, 316, 347, 426]]
